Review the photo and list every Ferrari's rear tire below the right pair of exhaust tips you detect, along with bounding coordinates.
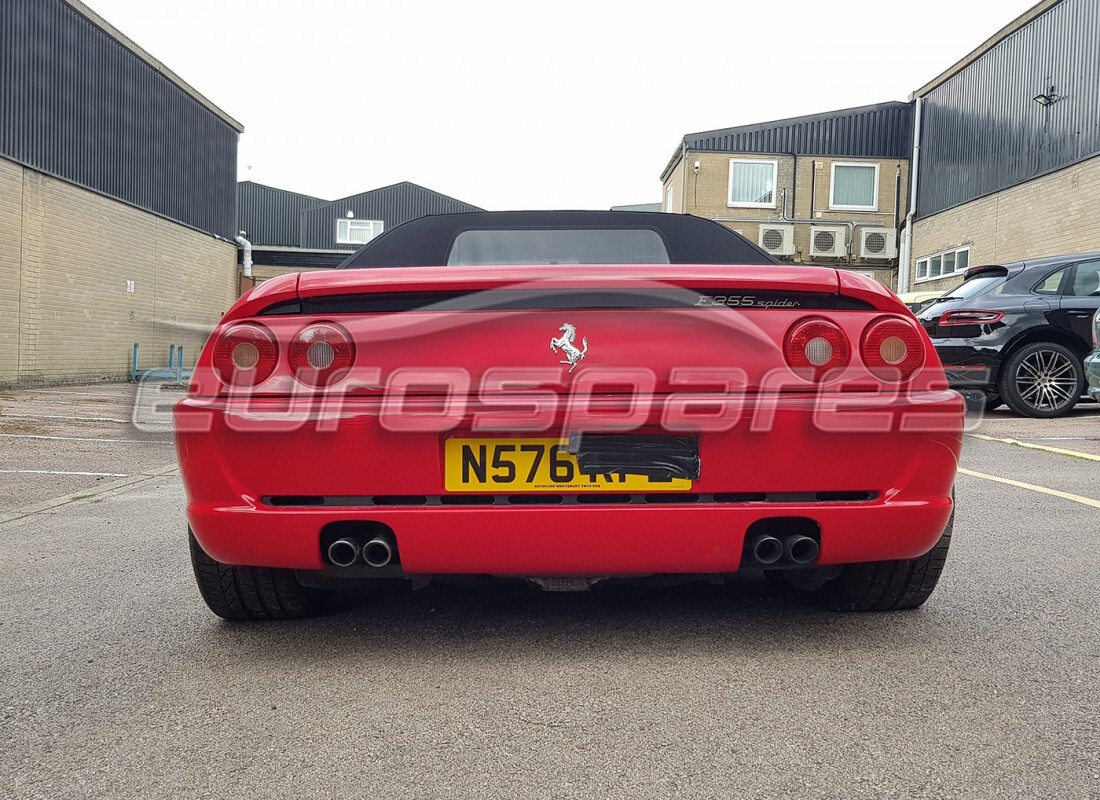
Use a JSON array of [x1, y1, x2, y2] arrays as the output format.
[[766, 511, 955, 611]]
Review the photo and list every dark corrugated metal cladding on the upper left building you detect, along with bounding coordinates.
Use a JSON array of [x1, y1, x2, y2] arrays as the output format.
[[0, 0, 238, 237]]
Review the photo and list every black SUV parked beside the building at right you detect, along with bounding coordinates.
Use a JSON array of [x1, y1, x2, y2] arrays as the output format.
[[917, 253, 1100, 417]]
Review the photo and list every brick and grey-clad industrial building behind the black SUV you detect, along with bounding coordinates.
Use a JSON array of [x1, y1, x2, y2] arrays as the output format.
[[901, 0, 1100, 291]]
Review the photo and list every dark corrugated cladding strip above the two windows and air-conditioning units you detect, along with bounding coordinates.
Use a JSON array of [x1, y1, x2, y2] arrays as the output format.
[[684, 102, 913, 158]]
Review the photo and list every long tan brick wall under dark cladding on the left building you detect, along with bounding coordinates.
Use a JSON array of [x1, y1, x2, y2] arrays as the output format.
[[0, 160, 237, 384]]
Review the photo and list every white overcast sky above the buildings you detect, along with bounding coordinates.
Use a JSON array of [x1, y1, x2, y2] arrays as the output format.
[[85, 0, 1033, 210]]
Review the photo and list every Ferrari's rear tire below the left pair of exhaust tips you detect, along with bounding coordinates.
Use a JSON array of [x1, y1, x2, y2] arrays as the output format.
[[187, 529, 325, 620]]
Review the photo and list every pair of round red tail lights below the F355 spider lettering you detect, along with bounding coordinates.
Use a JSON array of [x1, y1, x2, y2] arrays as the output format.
[[783, 317, 924, 382]]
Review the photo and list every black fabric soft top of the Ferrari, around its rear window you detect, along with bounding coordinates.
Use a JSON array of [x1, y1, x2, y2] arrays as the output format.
[[337, 211, 780, 270]]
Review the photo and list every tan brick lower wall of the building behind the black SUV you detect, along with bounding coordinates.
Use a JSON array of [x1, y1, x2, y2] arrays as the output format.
[[910, 151, 1100, 291]]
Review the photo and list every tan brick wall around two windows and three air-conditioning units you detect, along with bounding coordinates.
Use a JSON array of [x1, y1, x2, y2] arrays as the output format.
[[662, 151, 909, 287]]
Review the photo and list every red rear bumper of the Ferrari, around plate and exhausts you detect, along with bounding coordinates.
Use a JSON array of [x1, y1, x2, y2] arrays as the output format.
[[176, 391, 963, 576]]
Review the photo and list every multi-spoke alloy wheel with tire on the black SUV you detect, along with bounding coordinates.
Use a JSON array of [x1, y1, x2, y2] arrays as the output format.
[[1000, 342, 1085, 419]]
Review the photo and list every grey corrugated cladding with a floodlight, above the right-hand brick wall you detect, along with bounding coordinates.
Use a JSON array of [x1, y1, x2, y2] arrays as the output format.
[[916, 0, 1100, 216]]
